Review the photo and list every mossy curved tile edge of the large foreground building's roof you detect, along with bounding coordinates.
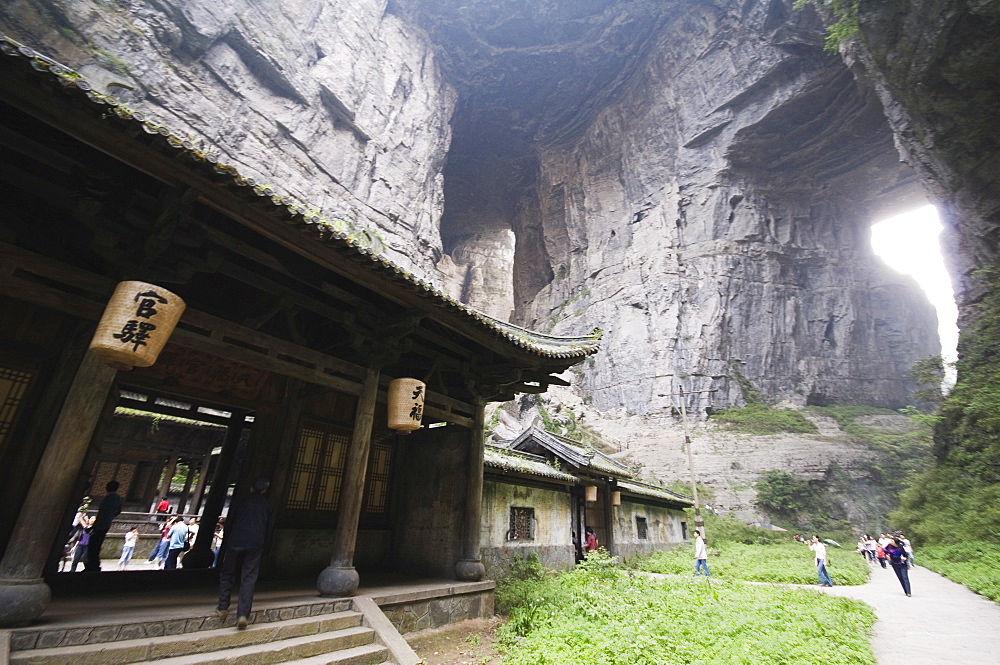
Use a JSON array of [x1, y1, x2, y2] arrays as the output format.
[[0, 33, 602, 359]]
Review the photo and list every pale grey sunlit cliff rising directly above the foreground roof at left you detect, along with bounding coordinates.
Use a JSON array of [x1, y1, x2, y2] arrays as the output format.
[[0, 0, 454, 272]]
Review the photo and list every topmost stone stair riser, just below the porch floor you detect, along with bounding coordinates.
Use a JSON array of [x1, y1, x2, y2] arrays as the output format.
[[10, 599, 351, 651]]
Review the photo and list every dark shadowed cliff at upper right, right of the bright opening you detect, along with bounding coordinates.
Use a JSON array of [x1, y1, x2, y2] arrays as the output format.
[[842, 0, 1000, 314]]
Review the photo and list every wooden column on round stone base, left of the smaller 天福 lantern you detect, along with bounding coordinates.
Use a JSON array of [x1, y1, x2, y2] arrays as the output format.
[[316, 367, 380, 597]]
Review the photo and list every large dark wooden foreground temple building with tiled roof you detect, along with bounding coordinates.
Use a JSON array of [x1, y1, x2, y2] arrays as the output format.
[[0, 39, 600, 625]]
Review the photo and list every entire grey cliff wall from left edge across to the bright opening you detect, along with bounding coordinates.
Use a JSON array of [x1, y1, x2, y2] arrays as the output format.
[[0, 0, 939, 413]]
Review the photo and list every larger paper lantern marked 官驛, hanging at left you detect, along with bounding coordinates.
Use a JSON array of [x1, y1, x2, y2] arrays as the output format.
[[90, 282, 186, 369]]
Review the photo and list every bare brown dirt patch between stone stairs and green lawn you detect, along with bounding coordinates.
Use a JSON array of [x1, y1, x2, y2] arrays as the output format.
[[404, 617, 501, 665]]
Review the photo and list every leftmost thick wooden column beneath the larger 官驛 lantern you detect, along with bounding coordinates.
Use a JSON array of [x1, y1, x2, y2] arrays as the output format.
[[0, 353, 116, 627]]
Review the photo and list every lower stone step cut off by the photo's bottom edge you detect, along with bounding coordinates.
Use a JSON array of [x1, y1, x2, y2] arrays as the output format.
[[121, 628, 389, 665]]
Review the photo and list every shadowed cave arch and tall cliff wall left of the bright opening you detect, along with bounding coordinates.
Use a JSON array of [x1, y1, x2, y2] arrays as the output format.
[[416, 1, 940, 414]]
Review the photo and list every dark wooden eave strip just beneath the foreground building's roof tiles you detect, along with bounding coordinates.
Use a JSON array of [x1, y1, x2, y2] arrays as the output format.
[[0, 48, 597, 366]]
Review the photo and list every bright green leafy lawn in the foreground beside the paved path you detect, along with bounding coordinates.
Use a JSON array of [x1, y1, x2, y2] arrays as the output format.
[[498, 546, 875, 665]]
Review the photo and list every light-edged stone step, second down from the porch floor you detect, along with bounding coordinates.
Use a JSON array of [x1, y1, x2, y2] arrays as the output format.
[[10, 612, 374, 665]]
